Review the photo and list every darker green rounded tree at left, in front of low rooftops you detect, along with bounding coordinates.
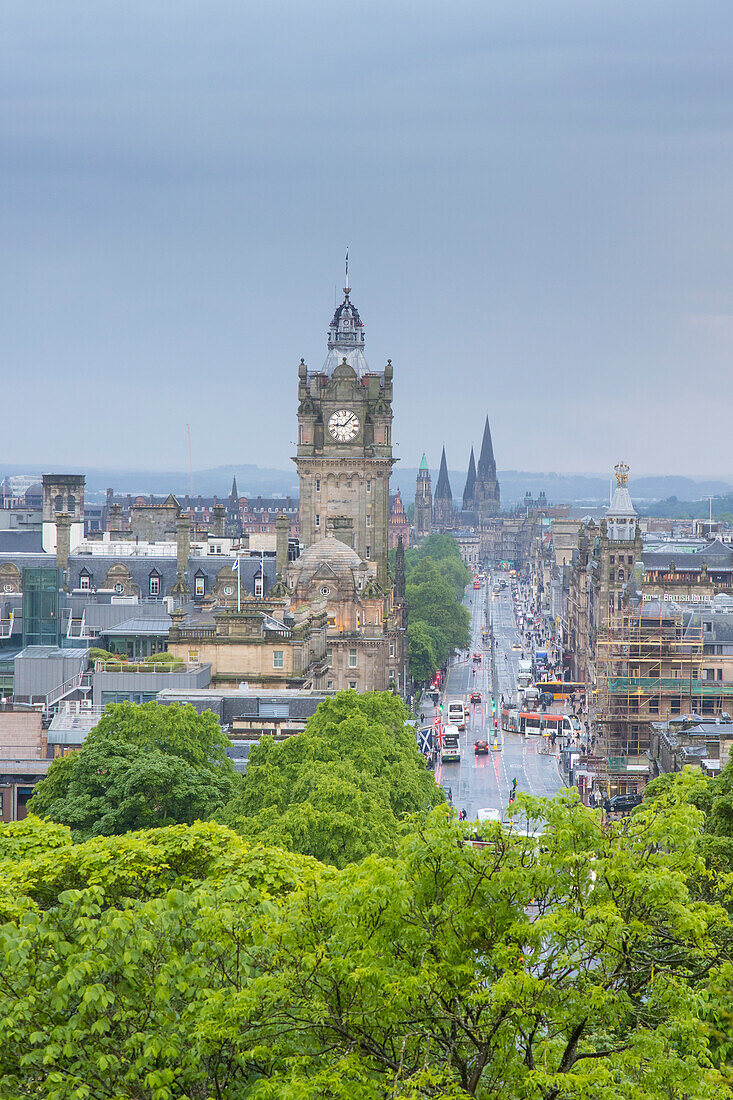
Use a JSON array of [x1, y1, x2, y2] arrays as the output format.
[[29, 703, 241, 840]]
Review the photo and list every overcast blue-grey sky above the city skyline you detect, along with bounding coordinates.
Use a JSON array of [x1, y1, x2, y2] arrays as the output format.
[[0, 0, 733, 476]]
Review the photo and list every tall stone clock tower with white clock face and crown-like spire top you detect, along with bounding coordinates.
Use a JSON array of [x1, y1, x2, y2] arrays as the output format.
[[294, 279, 395, 591]]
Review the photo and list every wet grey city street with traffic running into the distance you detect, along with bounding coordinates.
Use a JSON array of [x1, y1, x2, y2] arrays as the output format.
[[424, 574, 562, 818]]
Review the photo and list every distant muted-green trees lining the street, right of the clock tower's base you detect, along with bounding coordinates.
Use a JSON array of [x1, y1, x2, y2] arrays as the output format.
[[396, 535, 471, 682]]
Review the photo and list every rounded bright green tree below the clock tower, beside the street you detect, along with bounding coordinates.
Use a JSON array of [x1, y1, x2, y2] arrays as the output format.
[[217, 692, 442, 867]]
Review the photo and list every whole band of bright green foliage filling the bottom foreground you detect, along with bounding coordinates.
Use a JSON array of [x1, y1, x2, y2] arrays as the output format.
[[0, 777, 733, 1100]]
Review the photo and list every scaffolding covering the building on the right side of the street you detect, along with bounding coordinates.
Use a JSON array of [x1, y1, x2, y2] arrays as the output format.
[[589, 601, 704, 790]]
